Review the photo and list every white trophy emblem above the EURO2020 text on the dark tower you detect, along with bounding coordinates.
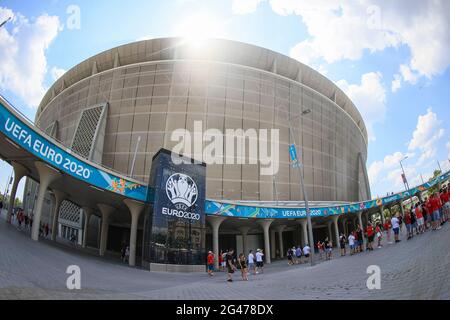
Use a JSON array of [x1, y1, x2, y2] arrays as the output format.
[[166, 173, 198, 211]]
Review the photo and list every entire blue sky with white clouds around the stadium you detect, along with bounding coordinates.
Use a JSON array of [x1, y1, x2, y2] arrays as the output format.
[[0, 0, 450, 197]]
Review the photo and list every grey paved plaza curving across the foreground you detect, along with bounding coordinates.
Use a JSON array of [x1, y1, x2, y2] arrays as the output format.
[[0, 210, 450, 300]]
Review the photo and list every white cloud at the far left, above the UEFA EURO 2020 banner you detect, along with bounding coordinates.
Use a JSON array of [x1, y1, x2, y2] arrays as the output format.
[[0, 7, 61, 106]]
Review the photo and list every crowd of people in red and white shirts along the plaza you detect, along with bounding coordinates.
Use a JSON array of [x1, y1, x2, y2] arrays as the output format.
[[207, 187, 450, 282]]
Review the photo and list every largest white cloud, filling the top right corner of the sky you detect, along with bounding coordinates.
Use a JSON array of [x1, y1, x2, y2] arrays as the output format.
[[248, 0, 450, 82]]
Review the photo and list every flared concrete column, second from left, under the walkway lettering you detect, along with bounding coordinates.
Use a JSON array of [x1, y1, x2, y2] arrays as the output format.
[[31, 161, 61, 241]]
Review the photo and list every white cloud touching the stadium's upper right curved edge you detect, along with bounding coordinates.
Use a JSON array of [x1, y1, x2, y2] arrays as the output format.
[[336, 72, 387, 140]]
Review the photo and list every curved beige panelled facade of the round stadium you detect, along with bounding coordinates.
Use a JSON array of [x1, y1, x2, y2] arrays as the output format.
[[24, 38, 370, 260]]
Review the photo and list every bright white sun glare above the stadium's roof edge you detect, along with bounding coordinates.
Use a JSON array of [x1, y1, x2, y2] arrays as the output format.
[[175, 12, 226, 47]]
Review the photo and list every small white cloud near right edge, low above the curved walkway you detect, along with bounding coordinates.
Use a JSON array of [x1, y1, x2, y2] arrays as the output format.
[[408, 108, 444, 165]]
